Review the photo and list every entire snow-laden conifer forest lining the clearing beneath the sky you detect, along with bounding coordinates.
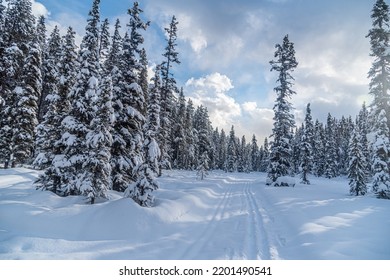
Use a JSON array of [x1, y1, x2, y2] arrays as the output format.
[[0, 0, 390, 207]]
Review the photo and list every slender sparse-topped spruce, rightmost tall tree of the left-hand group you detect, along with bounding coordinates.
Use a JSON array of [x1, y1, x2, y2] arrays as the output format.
[[158, 16, 180, 175]]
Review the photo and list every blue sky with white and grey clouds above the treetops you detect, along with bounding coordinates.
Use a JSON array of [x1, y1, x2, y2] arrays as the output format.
[[29, 0, 375, 143]]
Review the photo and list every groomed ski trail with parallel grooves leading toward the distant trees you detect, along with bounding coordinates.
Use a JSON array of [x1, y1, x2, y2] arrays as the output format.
[[181, 178, 279, 260]]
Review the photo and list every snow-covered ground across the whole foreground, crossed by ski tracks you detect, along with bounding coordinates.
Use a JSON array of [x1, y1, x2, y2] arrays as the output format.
[[0, 168, 390, 260]]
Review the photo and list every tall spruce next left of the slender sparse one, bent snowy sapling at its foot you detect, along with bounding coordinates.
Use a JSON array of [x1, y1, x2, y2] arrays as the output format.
[[123, 2, 160, 207]]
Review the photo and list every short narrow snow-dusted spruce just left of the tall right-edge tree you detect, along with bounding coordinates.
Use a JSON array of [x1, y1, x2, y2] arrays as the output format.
[[348, 119, 368, 196]]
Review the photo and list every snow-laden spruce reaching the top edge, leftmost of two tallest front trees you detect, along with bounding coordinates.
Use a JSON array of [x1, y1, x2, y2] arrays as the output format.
[[58, 0, 104, 199]]
